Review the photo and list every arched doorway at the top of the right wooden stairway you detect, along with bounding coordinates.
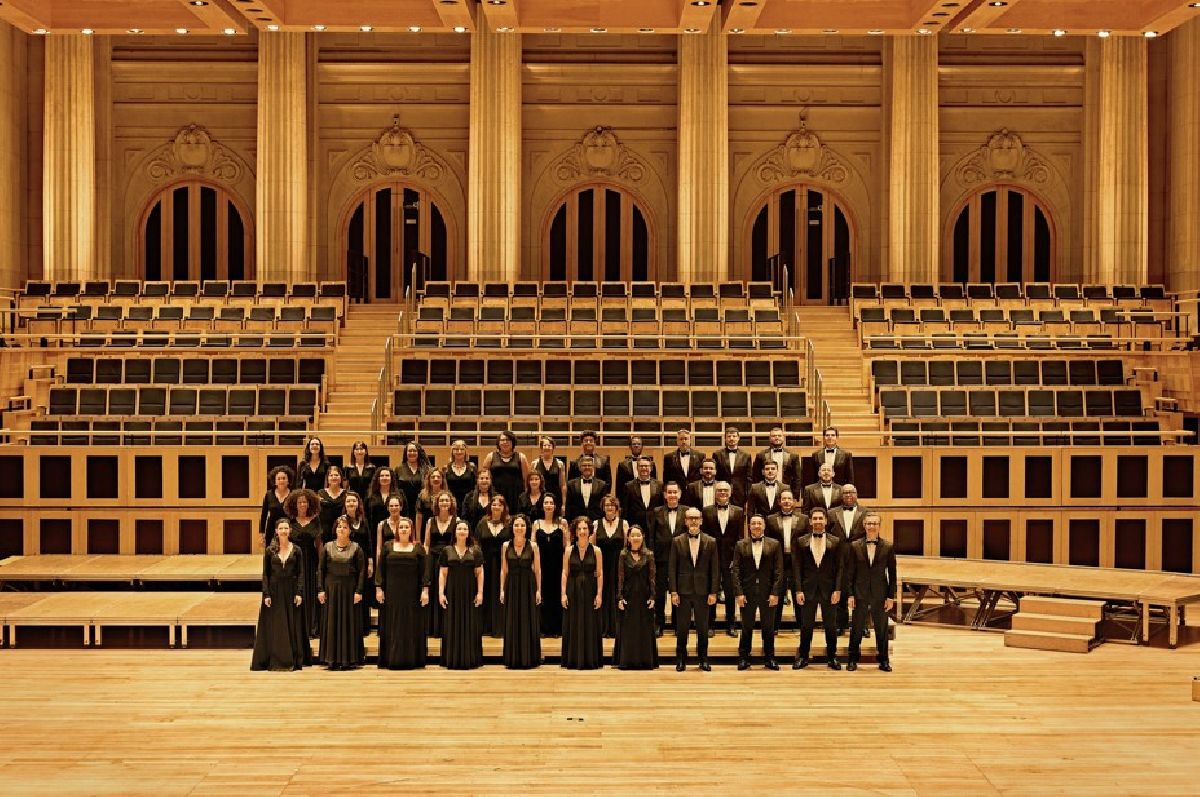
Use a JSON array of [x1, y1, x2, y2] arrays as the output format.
[[745, 185, 854, 305]]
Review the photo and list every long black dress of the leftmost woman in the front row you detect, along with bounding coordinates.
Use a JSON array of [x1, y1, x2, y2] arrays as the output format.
[[250, 544, 312, 671]]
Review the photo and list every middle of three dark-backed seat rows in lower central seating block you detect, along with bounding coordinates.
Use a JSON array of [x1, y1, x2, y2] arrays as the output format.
[[392, 386, 808, 420]]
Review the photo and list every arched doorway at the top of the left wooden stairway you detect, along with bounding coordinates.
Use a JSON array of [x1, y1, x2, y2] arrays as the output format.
[[342, 182, 454, 301]]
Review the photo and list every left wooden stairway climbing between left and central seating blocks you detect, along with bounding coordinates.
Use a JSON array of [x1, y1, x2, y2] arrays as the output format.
[[317, 305, 401, 451]]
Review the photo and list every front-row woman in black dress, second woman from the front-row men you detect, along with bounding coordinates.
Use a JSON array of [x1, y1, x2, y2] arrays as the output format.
[[563, 517, 604, 670]]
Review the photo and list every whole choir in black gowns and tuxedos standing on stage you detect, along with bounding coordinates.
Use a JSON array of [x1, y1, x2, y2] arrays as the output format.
[[251, 427, 896, 671]]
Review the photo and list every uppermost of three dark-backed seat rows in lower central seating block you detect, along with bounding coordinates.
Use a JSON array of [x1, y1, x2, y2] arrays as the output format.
[[398, 356, 804, 388]]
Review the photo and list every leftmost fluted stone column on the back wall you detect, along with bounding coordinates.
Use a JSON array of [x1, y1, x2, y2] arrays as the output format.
[[42, 34, 97, 280]]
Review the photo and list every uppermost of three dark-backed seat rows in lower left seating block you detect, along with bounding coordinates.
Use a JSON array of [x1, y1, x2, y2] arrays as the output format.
[[66, 356, 325, 385]]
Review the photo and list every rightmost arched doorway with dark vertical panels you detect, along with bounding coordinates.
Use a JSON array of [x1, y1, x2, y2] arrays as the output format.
[[942, 185, 1054, 283]]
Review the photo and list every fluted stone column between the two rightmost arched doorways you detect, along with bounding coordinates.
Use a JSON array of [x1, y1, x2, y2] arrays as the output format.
[[884, 36, 941, 282]]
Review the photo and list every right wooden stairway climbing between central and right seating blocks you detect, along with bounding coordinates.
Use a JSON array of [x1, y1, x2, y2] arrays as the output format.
[[792, 306, 882, 450]]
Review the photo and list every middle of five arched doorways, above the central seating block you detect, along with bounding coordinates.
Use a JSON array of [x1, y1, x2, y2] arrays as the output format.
[[542, 185, 655, 282]]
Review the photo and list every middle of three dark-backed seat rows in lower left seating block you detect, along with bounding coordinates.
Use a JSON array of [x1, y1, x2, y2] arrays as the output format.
[[47, 385, 318, 418]]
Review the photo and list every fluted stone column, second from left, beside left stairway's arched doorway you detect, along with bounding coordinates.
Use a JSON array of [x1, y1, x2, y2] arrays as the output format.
[[254, 31, 314, 282]]
